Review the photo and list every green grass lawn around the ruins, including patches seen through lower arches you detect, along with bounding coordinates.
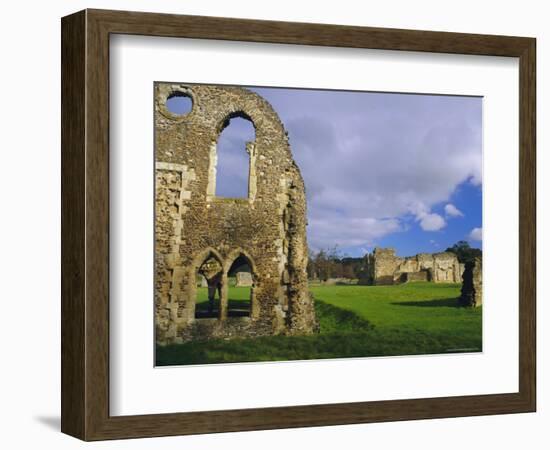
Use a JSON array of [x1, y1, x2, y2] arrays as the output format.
[[156, 283, 481, 365]]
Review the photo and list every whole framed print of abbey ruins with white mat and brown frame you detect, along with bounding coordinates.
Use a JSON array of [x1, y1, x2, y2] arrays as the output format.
[[62, 10, 536, 440]]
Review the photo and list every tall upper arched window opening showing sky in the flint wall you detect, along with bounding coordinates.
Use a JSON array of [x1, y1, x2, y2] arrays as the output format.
[[215, 112, 256, 198]]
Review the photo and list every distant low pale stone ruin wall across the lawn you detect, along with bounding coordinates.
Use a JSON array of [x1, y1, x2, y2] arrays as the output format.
[[362, 248, 464, 285]]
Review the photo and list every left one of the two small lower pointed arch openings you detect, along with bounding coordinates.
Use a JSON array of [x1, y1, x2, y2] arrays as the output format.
[[195, 253, 224, 319]]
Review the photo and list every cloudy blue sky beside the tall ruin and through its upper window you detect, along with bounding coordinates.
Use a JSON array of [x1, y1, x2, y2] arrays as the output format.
[[199, 88, 488, 257]]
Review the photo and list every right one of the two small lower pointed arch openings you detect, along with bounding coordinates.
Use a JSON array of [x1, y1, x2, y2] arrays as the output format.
[[227, 254, 254, 317]]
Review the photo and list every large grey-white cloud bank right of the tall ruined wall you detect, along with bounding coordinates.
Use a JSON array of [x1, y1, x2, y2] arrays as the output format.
[[248, 88, 482, 248]]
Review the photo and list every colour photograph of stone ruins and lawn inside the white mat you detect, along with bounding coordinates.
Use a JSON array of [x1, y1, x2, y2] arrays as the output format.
[[154, 81, 483, 366]]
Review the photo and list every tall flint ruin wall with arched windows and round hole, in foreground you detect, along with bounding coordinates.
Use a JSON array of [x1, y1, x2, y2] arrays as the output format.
[[155, 83, 318, 344]]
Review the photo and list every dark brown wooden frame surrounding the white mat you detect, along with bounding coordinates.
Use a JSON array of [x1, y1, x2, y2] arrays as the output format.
[[61, 10, 536, 440]]
